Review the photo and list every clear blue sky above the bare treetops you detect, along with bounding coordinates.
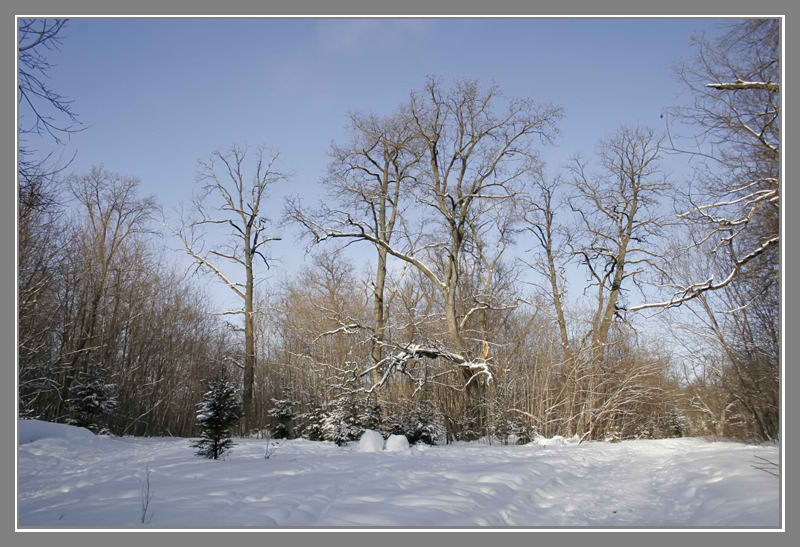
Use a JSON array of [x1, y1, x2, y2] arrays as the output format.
[[23, 19, 730, 312]]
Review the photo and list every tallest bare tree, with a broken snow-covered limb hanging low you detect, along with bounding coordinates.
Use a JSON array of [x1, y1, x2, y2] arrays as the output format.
[[290, 78, 562, 392]]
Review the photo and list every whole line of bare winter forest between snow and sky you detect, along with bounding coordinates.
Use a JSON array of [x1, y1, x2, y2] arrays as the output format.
[[18, 20, 781, 442]]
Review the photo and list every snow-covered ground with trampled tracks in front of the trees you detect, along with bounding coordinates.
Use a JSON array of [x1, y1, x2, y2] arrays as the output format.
[[18, 420, 779, 528]]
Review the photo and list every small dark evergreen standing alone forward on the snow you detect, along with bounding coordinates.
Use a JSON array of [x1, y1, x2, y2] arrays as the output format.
[[192, 373, 243, 460]]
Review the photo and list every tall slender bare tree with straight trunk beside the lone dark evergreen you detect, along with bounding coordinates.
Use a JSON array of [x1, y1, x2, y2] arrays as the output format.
[[164, 145, 289, 431]]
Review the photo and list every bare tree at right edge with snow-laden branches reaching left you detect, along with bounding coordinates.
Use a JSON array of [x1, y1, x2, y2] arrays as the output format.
[[630, 19, 781, 311]]
